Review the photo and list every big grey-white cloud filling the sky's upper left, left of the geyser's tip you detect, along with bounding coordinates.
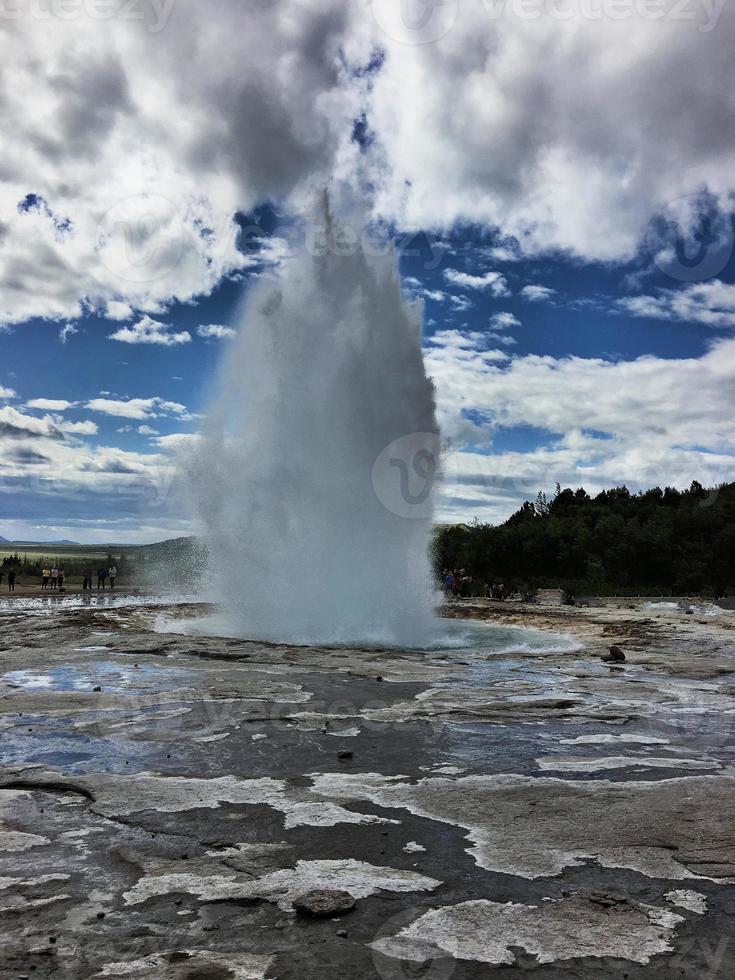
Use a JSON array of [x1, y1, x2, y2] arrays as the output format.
[[0, 0, 372, 323]]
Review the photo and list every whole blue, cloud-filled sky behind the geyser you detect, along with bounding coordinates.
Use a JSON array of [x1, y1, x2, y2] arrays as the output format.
[[0, 0, 735, 543]]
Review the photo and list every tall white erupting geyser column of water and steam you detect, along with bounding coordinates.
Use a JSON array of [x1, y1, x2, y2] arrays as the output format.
[[195, 195, 439, 646]]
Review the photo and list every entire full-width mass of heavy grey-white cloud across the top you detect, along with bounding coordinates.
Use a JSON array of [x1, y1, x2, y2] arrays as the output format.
[[5, 0, 735, 334]]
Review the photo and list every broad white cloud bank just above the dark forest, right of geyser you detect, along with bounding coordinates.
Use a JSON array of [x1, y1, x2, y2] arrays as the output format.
[[426, 331, 735, 520]]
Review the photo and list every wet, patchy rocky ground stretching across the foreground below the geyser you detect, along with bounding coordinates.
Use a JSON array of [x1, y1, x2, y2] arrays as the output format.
[[0, 596, 735, 980]]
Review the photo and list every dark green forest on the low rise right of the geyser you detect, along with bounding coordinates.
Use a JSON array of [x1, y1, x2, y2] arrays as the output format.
[[434, 482, 735, 598]]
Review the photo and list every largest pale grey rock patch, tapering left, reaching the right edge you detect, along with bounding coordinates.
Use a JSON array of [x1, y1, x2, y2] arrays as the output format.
[[313, 773, 735, 884]]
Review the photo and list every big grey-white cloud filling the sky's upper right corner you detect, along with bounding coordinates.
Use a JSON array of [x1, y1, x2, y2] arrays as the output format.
[[368, 0, 735, 261]]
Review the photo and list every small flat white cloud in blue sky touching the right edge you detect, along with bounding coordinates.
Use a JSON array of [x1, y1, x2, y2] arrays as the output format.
[[618, 279, 735, 327]]
